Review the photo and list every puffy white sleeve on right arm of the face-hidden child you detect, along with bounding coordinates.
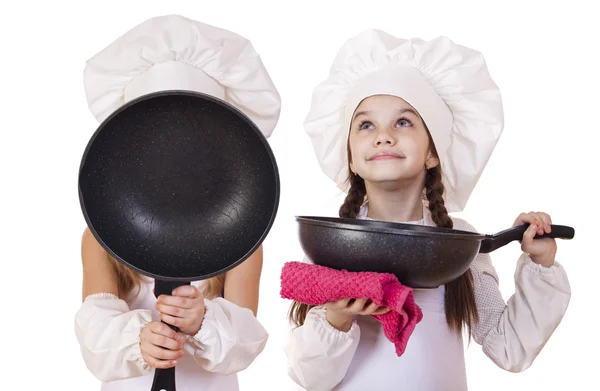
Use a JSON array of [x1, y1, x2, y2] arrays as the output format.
[[185, 297, 269, 375]]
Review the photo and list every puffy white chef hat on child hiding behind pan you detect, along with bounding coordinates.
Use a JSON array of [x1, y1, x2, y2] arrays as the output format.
[[84, 15, 281, 137]]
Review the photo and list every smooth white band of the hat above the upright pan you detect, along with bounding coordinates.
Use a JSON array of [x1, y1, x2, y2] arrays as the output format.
[[124, 61, 225, 102]]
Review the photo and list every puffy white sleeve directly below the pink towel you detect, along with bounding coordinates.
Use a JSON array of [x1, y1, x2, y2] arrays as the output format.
[[284, 306, 360, 391]]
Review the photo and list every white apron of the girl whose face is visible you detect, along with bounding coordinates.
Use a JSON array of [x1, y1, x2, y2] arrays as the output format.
[[334, 286, 467, 391]]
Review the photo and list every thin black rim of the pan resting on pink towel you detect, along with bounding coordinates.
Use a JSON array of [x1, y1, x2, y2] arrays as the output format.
[[296, 215, 486, 240]]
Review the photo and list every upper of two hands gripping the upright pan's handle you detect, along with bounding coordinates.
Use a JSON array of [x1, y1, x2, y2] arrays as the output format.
[[156, 285, 204, 335]]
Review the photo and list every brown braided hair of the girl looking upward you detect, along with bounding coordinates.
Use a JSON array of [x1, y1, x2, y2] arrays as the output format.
[[288, 135, 479, 340]]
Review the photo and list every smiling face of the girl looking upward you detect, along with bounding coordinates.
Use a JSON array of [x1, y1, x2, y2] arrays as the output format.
[[348, 95, 439, 187]]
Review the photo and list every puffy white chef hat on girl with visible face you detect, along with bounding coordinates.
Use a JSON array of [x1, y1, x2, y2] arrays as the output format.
[[304, 30, 504, 212]]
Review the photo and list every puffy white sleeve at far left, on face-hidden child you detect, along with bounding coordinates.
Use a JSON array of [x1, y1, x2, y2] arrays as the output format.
[[75, 293, 152, 381]]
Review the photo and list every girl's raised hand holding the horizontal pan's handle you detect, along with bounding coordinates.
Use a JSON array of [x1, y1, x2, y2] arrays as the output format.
[[513, 212, 556, 267]]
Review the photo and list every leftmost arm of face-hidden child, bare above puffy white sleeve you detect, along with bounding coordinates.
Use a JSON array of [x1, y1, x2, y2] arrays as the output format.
[[75, 230, 151, 381]]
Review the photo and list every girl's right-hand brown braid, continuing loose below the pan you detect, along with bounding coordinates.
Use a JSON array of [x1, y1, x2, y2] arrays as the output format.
[[425, 166, 479, 339]]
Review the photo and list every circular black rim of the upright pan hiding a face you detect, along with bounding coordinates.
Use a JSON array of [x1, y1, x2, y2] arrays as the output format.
[[77, 90, 281, 282]]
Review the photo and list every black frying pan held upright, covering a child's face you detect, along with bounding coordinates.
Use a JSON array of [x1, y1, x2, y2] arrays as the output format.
[[79, 91, 280, 391]]
